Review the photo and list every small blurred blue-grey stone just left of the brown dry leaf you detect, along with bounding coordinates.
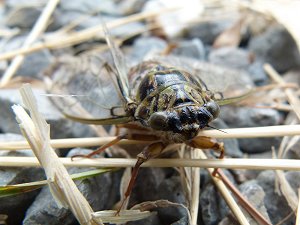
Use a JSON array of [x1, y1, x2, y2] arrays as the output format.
[[172, 38, 206, 60]]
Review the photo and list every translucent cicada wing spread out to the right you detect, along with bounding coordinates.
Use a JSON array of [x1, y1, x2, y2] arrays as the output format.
[[152, 56, 254, 105]]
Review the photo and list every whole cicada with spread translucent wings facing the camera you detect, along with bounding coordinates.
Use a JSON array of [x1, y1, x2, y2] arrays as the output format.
[[51, 24, 251, 213]]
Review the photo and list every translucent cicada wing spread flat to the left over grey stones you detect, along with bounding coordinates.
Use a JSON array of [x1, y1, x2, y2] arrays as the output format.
[[48, 54, 130, 124]]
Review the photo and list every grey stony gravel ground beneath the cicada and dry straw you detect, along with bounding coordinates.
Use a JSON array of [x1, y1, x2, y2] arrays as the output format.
[[0, 0, 300, 225]]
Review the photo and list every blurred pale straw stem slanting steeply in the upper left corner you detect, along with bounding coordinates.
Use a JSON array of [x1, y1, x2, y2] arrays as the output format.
[[0, 0, 59, 87]]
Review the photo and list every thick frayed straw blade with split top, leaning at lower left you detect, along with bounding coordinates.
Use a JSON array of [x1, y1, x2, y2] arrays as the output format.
[[13, 85, 102, 225]]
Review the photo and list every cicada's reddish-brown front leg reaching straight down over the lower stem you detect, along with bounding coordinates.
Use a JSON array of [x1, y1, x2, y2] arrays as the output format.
[[116, 142, 166, 215]]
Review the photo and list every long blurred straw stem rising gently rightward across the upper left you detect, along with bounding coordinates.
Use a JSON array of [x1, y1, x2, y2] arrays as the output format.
[[0, 8, 178, 60]]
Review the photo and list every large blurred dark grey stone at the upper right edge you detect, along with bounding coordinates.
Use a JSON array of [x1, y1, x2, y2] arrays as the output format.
[[249, 25, 300, 73]]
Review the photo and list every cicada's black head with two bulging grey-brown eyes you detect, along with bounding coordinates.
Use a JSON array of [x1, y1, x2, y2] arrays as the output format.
[[148, 100, 220, 142]]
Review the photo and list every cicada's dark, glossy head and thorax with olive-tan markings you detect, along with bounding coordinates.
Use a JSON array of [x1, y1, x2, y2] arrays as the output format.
[[130, 62, 219, 143]]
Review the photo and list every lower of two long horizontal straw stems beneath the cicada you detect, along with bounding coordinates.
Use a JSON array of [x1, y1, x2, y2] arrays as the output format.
[[0, 156, 300, 171]]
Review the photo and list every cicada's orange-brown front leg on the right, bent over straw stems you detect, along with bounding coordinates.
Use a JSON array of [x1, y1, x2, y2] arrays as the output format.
[[187, 136, 225, 176]]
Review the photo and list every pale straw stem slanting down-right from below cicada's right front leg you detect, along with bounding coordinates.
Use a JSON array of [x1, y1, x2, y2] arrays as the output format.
[[199, 151, 250, 225]]
